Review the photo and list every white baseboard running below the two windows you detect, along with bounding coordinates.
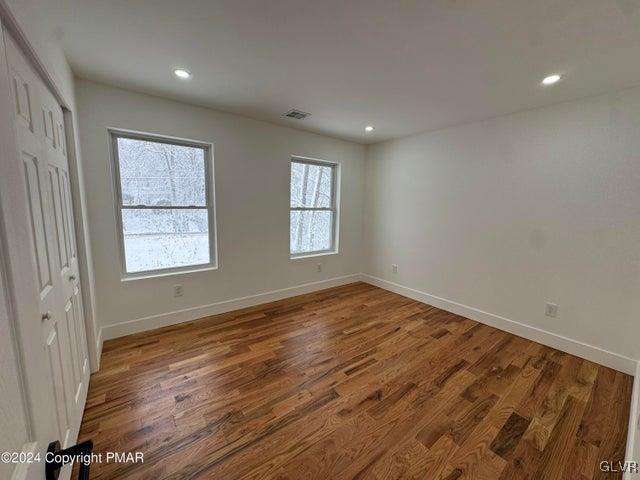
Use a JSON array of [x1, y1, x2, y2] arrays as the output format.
[[98, 273, 362, 342]]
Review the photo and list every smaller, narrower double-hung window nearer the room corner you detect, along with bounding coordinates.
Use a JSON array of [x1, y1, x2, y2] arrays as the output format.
[[289, 158, 337, 257]]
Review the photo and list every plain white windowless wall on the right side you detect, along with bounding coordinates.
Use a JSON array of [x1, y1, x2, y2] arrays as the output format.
[[364, 88, 640, 364]]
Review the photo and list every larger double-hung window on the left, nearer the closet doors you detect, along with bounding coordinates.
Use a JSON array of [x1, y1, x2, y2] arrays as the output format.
[[111, 131, 216, 275]]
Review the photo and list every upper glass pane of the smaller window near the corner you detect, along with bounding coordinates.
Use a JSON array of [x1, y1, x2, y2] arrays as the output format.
[[291, 162, 333, 208]]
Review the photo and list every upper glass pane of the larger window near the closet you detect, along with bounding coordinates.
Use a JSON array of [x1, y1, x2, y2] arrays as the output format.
[[118, 137, 207, 206]]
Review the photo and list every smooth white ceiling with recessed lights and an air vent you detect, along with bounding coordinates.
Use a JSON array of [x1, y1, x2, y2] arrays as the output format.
[[40, 0, 640, 143]]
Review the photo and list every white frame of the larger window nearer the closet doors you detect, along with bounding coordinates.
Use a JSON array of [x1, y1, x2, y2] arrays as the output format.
[[108, 128, 218, 280]]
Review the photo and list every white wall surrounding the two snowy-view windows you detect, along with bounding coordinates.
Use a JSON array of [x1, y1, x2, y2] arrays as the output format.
[[76, 80, 365, 337]]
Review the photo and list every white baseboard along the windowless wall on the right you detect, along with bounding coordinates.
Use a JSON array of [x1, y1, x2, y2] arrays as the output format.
[[362, 274, 637, 375]]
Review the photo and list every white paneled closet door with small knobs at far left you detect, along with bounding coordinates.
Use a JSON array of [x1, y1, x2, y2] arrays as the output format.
[[4, 32, 90, 478]]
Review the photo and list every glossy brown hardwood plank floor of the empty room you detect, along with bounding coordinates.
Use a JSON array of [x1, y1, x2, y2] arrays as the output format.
[[81, 283, 632, 480]]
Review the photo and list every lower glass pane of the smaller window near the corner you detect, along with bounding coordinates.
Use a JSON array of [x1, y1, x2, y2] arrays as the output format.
[[290, 210, 333, 254]]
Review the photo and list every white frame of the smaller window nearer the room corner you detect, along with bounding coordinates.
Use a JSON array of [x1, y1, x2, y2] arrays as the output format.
[[289, 155, 340, 259]]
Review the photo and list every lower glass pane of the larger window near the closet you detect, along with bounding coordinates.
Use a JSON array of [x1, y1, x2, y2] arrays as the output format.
[[122, 208, 210, 273]]
